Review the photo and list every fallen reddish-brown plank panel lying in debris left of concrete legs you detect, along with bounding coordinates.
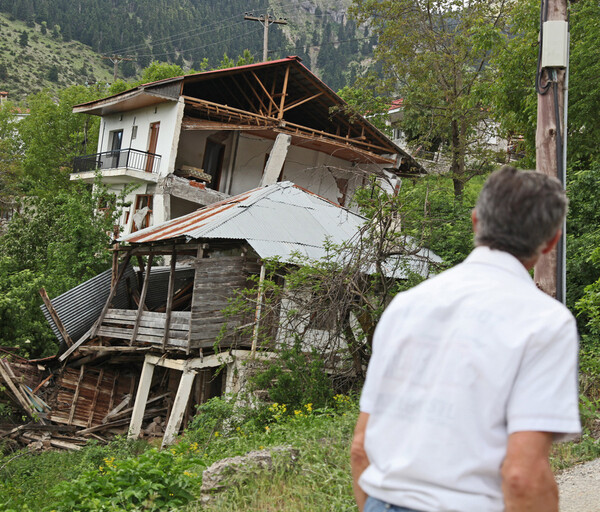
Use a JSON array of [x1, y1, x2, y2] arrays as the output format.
[[48, 368, 136, 428]]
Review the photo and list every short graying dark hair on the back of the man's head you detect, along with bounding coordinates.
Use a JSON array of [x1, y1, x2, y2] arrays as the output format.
[[475, 165, 568, 260]]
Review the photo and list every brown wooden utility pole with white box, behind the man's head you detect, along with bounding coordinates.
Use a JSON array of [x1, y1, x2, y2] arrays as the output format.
[[534, 0, 569, 303]]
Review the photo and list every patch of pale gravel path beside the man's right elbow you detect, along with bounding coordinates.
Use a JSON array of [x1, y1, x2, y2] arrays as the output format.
[[556, 459, 600, 512]]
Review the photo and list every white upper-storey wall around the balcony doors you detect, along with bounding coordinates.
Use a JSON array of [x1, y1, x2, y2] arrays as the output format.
[[98, 101, 180, 176]]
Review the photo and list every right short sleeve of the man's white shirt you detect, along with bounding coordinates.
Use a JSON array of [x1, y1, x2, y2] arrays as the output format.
[[507, 315, 581, 441]]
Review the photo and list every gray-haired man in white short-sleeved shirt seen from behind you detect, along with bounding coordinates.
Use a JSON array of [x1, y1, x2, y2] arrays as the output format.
[[351, 166, 580, 512]]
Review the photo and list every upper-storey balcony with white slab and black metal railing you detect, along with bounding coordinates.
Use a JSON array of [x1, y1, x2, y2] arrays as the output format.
[[71, 148, 161, 183]]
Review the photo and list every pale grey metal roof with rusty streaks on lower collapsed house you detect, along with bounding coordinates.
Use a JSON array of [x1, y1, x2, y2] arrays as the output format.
[[119, 181, 441, 277]]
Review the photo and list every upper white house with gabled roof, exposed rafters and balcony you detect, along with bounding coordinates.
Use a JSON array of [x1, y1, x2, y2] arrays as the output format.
[[71, 57, 423, 233]]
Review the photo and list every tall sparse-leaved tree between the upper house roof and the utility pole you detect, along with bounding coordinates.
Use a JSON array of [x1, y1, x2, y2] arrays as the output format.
[[352, 0, 508, 198]]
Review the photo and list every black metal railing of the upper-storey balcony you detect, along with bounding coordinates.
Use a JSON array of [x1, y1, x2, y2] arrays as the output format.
[[73, 149, 160, 173]]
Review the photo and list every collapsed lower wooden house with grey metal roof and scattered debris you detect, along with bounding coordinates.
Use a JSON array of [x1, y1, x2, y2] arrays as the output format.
[[0, 182, 440, 448]]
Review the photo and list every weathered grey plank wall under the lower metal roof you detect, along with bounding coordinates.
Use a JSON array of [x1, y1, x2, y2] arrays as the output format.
[[190, 256, 260, 348]]
